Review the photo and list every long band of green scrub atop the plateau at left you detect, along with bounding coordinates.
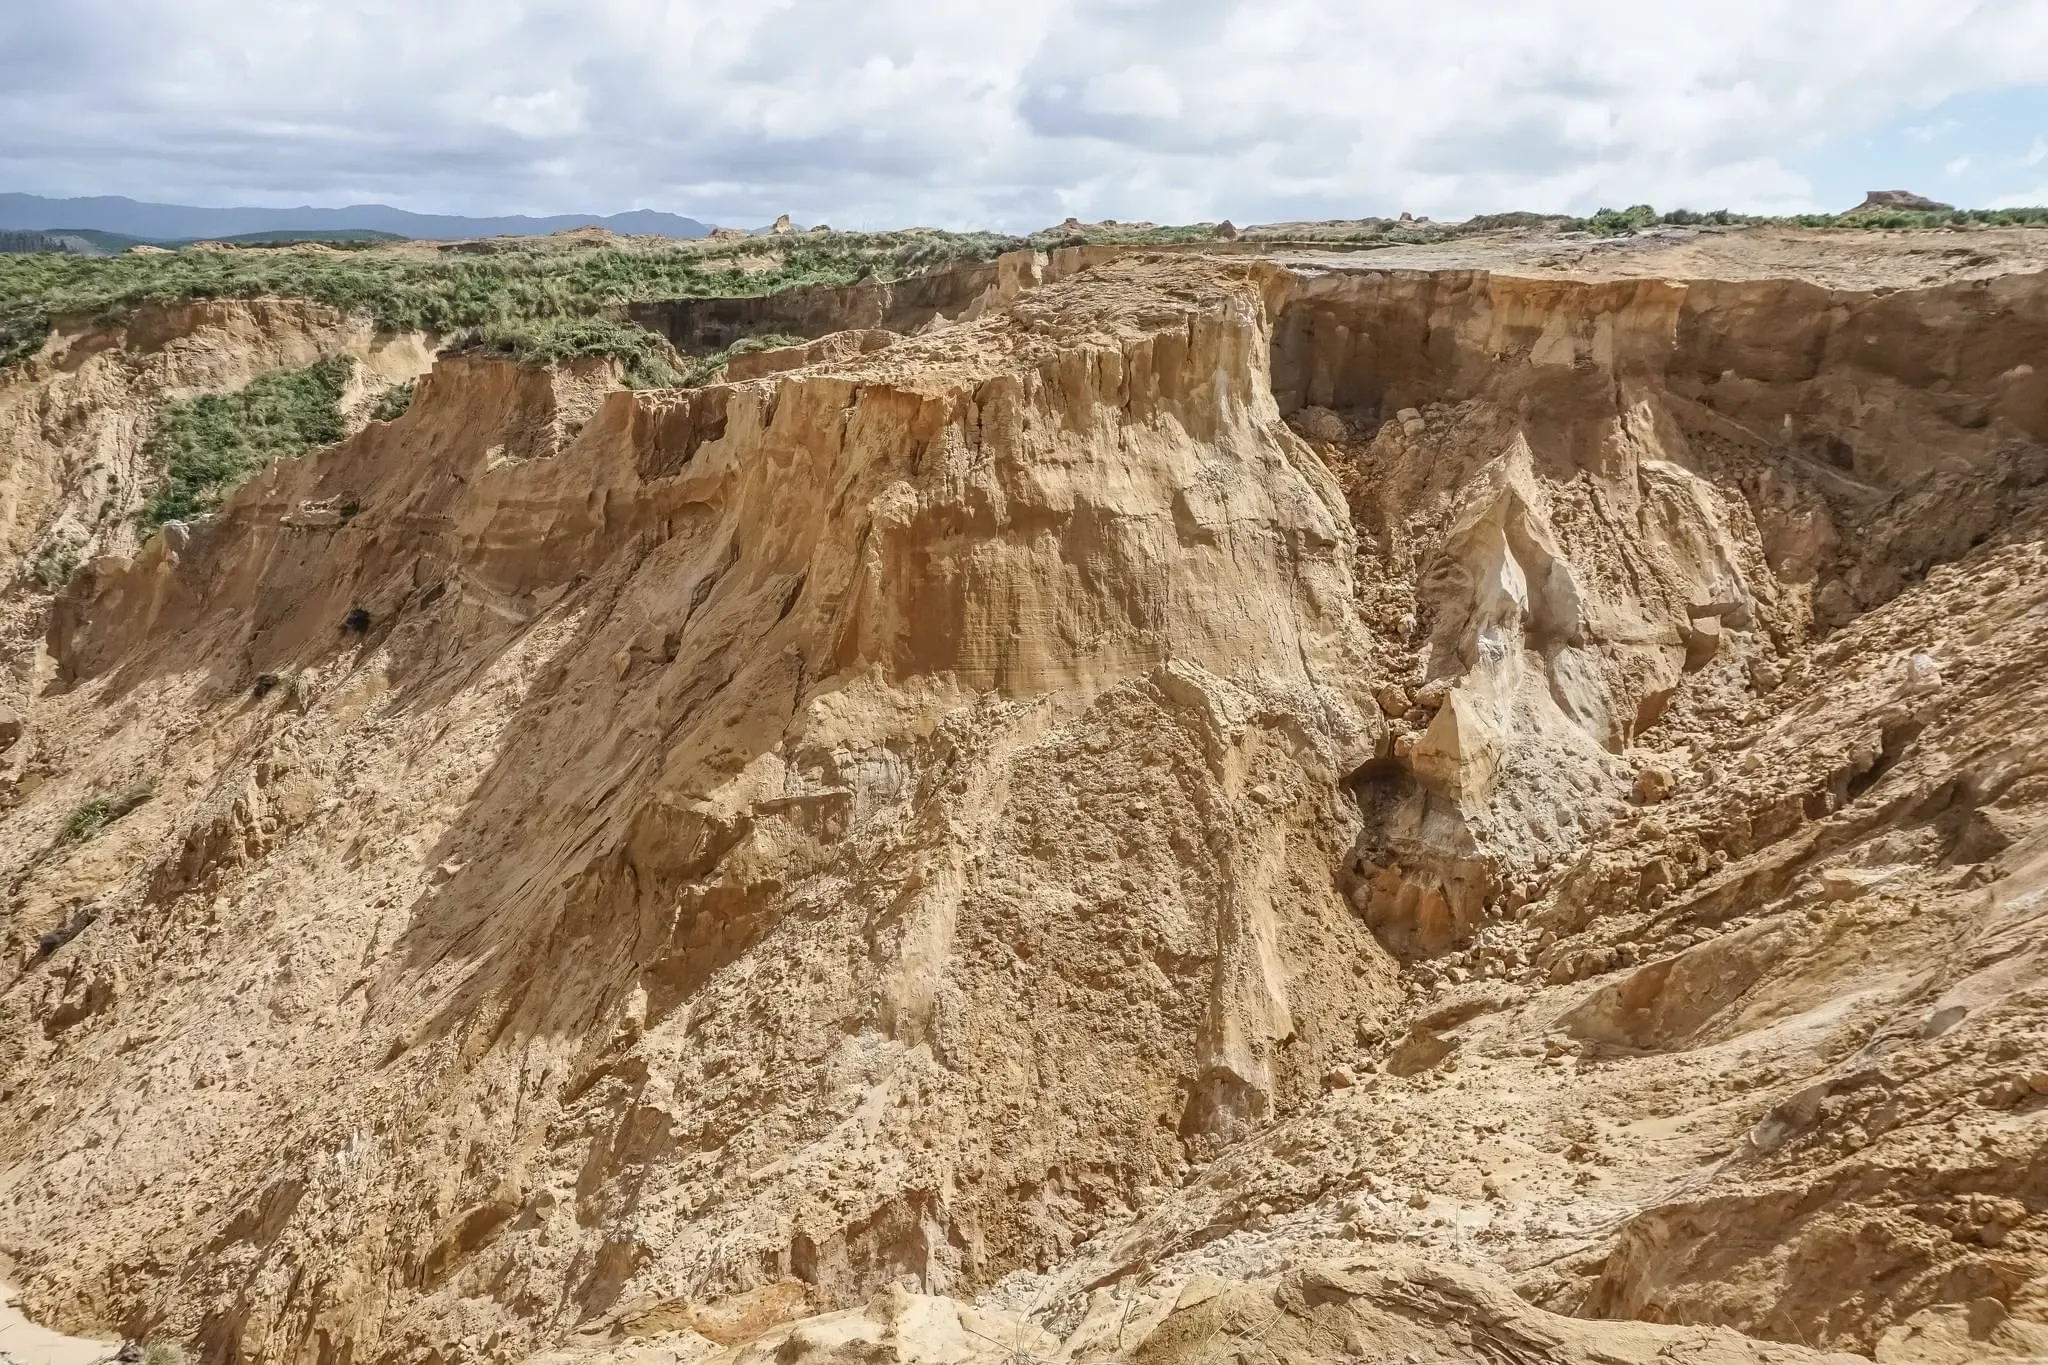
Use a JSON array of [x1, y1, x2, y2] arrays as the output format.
[[0, 231, 1022, 370]]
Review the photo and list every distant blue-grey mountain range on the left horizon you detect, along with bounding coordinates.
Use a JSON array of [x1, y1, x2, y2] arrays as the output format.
[[0, 194, 711, 241]]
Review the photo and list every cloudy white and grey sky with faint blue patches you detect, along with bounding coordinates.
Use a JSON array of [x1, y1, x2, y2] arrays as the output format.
[[0, 0, 2048, 231]]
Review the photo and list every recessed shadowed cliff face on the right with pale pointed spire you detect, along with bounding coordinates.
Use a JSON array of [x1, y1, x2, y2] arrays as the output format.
[[1274, 272, 2048, 954]]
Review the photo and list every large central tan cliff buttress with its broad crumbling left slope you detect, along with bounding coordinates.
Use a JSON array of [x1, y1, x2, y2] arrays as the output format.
[[8, 261, 1393, 1355]]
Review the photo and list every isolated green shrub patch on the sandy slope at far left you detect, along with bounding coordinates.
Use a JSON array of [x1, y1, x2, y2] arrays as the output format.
[[137, 356, 352, 528]]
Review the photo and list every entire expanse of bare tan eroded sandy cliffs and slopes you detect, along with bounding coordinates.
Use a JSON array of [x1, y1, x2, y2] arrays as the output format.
[[0, 231, 2048, 1365]]
